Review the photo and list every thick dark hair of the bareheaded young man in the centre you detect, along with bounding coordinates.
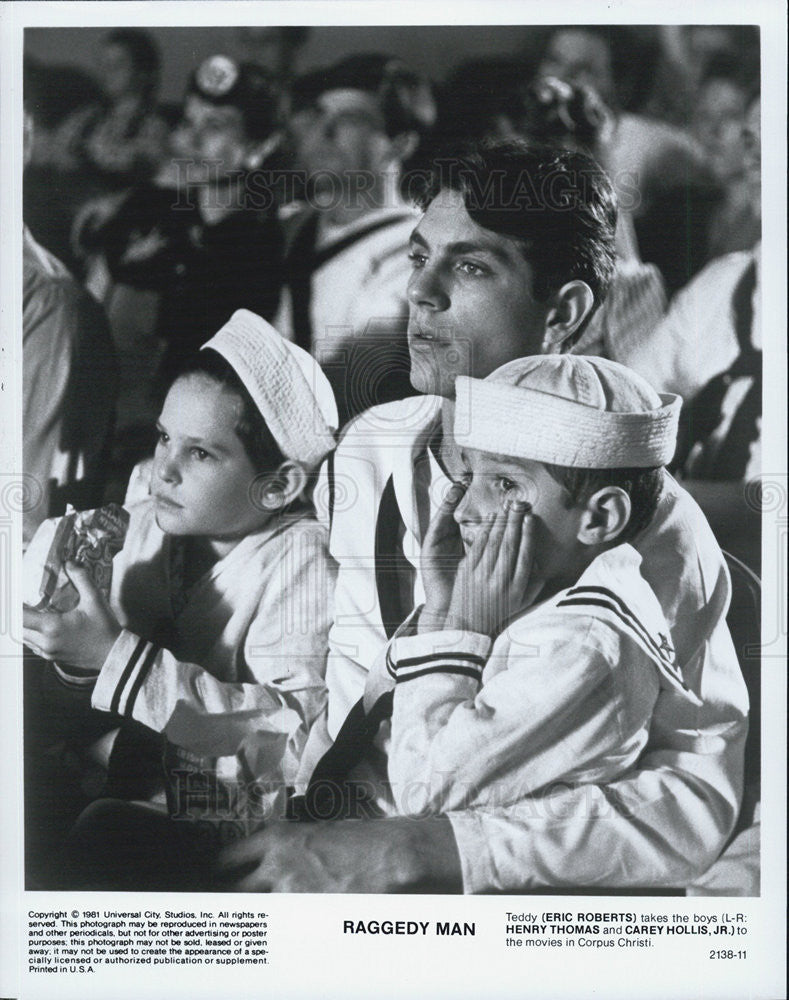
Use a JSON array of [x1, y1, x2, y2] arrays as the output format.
[[416, 139, 617, 316]]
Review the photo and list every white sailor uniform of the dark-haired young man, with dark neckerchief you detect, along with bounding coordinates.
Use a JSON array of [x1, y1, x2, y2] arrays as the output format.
[[305, 396, 748, 892]]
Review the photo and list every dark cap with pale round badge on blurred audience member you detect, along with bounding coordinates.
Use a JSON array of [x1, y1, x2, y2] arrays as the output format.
[[186, 55, 278, 140]]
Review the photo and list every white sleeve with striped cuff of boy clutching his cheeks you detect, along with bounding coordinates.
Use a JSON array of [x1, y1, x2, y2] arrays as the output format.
[[389, 616, 658, 815]]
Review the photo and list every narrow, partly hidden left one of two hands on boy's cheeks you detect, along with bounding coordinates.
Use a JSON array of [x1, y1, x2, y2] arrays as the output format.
[[419, 483, 465, 631]]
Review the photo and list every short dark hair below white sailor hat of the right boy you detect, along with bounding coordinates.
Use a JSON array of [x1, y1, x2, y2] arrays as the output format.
[[543, 462, 663, 544]]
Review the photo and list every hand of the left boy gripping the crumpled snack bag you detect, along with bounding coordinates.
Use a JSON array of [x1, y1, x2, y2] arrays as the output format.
[[23, 563, 121, 673]]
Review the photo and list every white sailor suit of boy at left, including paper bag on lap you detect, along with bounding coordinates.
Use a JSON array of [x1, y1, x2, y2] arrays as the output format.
[[92, 498, 333, 829]]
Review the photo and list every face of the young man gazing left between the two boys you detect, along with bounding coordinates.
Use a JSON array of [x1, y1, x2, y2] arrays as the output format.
[[408, 189, 549, 398]]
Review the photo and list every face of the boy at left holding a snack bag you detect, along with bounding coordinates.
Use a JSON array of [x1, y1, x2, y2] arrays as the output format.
[[151, 374, 270, 541]]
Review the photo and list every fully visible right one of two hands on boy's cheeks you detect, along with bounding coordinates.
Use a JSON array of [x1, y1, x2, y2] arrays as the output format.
[[445, 501, 540, 637]]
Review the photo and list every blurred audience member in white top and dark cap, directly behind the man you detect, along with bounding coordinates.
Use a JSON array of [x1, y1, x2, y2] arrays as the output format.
[[274, 55, 435, 422]]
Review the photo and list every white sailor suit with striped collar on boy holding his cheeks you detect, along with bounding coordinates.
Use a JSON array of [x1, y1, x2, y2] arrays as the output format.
[[386, 544, 698, 815]]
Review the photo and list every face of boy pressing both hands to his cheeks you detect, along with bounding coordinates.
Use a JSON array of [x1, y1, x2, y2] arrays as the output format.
[[455, 448, 586, 585]]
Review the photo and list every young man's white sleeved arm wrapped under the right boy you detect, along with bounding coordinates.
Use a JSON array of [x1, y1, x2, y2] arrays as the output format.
[[450, 665, 747, 892]]
